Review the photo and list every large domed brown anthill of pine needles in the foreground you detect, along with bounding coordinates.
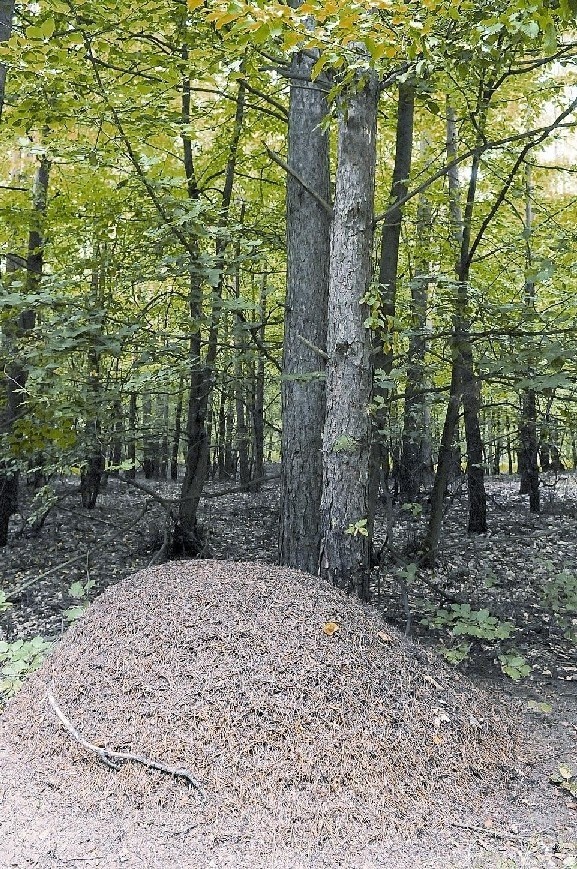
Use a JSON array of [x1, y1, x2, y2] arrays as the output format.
[[0, 561, 515, 865]]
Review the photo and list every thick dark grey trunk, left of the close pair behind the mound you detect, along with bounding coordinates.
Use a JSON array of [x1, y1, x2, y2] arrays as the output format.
[[279, 40, 330, 573]]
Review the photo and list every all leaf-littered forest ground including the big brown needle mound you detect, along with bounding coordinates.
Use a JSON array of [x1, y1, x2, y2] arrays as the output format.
[[0, 475, 577, 869]]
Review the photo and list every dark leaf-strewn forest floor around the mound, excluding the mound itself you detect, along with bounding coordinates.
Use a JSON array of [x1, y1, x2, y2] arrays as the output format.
[[0, 468, 577, 869]]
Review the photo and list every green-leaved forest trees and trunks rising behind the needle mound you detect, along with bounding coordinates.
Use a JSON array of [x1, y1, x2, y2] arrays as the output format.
[[0, 0, 577, 596]]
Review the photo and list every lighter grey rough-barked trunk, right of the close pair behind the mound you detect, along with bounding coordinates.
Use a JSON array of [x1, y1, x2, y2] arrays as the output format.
[[320, 68, 378, 598]]
